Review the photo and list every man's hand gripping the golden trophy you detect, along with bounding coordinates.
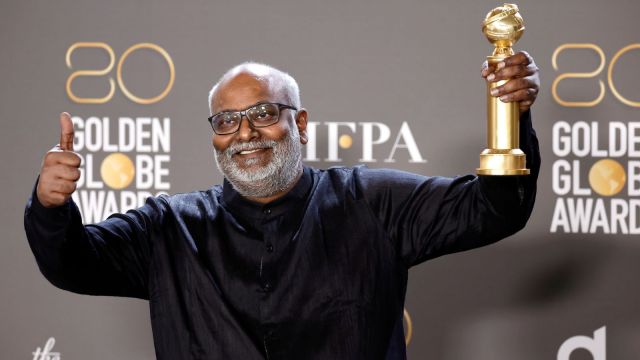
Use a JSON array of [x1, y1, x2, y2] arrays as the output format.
[[482, 51, 540, 113]]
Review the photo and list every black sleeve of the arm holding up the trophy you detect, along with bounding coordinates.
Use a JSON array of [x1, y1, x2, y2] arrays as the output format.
[[355, 112, 540, 267]]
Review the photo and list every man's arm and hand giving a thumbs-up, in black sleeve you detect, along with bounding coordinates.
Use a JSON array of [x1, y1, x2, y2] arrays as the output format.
[[24, 113, 162, 298]]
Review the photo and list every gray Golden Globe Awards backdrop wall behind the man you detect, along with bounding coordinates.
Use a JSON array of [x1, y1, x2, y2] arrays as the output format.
[[0, 0, 640, 360]]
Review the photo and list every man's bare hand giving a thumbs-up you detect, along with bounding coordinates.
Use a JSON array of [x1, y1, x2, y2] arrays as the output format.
[[36, 112, 80, 208]]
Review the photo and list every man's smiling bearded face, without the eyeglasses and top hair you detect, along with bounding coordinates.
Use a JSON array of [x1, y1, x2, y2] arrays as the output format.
[[211, 73, 306, 197]]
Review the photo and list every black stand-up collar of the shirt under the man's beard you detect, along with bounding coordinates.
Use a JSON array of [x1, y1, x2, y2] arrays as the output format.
[[222, 166, 313, 219]]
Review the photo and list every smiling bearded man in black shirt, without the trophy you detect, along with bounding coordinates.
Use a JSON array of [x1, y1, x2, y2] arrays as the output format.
[[25, 53, 540, 360]]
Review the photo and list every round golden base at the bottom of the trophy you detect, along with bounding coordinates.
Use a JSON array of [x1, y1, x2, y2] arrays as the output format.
[[476, 149, 531, 176]]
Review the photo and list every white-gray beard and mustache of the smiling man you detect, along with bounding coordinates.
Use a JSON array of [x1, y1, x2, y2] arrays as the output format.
[[215, 130, 302, 198]]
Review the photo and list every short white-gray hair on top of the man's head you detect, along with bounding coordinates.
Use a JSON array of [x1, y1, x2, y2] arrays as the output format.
[[209, 61, 301, 115]]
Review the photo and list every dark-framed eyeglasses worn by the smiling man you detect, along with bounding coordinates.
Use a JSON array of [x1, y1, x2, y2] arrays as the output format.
[[208, 103, 298, 135]]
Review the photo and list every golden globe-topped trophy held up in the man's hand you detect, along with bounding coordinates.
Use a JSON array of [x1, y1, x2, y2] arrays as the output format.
[[476, 4, 530, 175]]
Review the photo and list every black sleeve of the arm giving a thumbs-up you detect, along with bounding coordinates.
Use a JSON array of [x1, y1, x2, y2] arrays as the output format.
[[24, 179, 163, 299]]
